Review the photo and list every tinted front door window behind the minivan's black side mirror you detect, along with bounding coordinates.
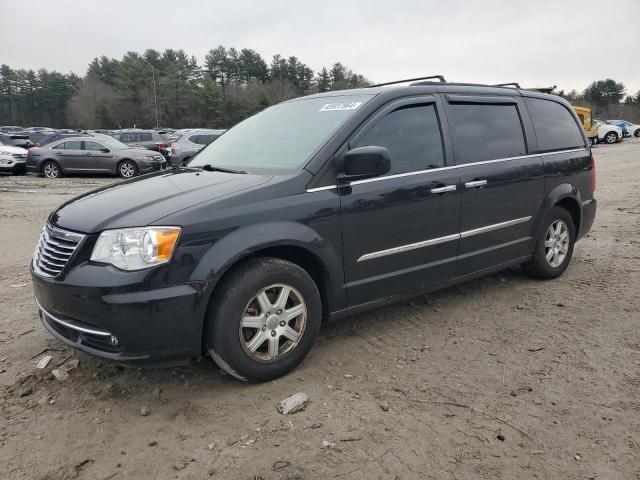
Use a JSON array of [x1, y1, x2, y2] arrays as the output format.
[[350, 105, 444, 175]]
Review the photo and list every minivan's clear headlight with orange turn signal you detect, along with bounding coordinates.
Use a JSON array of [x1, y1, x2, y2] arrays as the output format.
[[91, 227, 180, 270]]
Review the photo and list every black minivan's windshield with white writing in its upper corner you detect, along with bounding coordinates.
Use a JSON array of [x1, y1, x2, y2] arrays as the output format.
[[189, 95, 373, 174]]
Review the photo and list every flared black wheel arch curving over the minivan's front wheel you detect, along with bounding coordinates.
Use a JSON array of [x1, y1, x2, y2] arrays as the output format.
[[191, 221, 346, 307]]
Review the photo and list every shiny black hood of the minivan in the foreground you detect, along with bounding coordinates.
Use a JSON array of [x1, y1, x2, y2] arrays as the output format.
[[49, 170, 272, 233]]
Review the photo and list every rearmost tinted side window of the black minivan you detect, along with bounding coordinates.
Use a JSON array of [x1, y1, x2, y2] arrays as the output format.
[[525, 98, 584, 152]]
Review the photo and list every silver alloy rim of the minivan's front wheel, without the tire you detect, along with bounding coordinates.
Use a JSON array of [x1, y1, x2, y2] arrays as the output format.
[[239, 284, 307, 363]]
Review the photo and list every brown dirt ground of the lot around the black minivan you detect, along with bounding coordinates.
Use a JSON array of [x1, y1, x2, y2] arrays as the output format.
[[0, 139, 640, 480]]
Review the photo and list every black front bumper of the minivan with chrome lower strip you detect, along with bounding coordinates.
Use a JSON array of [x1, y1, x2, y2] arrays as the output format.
[[31, 264, 205, 366]]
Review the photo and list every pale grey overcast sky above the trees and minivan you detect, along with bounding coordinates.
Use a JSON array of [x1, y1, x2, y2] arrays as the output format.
[[0, 0, 640, 92]]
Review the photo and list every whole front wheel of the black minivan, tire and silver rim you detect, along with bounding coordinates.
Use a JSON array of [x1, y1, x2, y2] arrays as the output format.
[[204, 257, 322, 382]]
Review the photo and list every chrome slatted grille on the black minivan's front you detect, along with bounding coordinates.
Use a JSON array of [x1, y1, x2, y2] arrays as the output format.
[[33, 224, 84, 277]]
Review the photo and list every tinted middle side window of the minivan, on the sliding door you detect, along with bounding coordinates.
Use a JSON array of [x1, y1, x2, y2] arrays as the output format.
[[449, 103, 527, 165]]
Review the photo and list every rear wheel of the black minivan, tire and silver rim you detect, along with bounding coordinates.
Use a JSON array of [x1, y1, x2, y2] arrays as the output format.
[[524, 206, 576, 279]]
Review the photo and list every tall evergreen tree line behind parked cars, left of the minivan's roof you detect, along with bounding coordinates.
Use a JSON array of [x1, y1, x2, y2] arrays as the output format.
[[0, 46, 369, 128]]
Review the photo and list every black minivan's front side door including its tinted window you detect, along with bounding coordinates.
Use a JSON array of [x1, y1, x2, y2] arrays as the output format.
[[338, 96, 460, 307]]
